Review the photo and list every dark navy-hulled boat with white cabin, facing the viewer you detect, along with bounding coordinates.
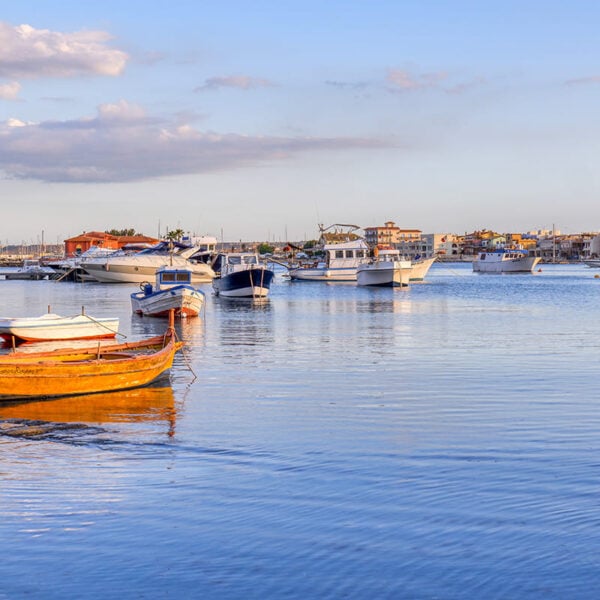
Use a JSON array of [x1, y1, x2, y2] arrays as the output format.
[[213, 252, 274, 298]]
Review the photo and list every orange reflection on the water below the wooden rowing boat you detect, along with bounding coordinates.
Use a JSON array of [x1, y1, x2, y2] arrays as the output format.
[[0, 386, 175, 424]]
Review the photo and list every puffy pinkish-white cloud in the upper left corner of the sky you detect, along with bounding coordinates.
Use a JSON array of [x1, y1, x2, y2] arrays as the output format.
[[0, 21, 129, 79]]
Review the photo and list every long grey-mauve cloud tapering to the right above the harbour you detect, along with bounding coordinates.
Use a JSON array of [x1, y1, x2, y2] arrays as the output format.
[[0, 101, 390, 182]]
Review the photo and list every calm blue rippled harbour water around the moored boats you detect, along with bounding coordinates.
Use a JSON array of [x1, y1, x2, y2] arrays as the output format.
[[0, 265, 600, 599]]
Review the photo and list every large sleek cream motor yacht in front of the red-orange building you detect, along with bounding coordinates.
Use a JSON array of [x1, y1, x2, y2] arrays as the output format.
[[81, 242, 215, 283]]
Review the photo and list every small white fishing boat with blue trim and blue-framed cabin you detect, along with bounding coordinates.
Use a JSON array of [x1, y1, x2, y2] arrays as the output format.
[[131, 266, 205, 317]]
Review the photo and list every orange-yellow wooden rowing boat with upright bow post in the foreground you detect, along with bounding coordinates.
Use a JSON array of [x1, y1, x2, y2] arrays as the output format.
[[0, 316, 183, 400]]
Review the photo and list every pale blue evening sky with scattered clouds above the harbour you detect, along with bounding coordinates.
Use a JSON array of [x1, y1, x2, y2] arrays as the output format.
[[0, 0, 600, 244]]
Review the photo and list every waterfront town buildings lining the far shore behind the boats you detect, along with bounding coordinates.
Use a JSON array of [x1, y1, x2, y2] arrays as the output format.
[[0, 221, 600, 265]]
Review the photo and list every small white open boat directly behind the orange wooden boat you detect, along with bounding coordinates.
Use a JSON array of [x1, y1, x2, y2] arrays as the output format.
[[0, 311, 119, 342]]
